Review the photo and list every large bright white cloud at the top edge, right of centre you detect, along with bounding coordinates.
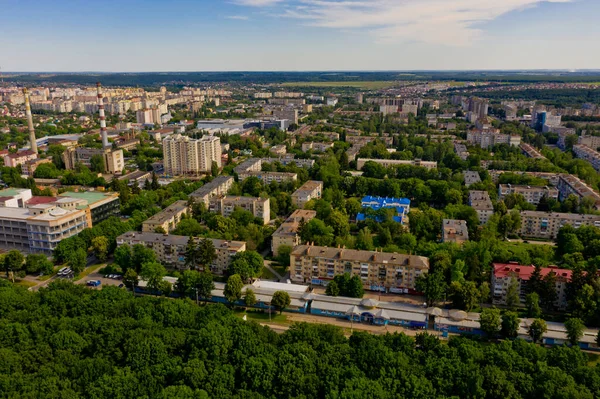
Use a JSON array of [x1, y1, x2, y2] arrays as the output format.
[[268, 0, 571, 46]]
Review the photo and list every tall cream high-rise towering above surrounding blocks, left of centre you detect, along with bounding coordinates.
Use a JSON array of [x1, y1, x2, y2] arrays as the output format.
[[162, 134, 221, 176]]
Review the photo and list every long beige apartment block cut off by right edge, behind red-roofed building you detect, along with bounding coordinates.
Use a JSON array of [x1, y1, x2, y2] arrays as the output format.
[[519, 211, 600, 239]]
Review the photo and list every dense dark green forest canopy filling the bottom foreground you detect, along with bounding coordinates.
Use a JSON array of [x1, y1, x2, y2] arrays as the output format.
[[0, 281, 600, 399]]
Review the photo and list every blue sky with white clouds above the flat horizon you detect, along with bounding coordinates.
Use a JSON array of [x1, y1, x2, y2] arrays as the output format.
[[0, 0, 600, 72]]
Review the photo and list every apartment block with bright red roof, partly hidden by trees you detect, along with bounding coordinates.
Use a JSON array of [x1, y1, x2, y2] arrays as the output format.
[[492, 263, 573, 309]]
